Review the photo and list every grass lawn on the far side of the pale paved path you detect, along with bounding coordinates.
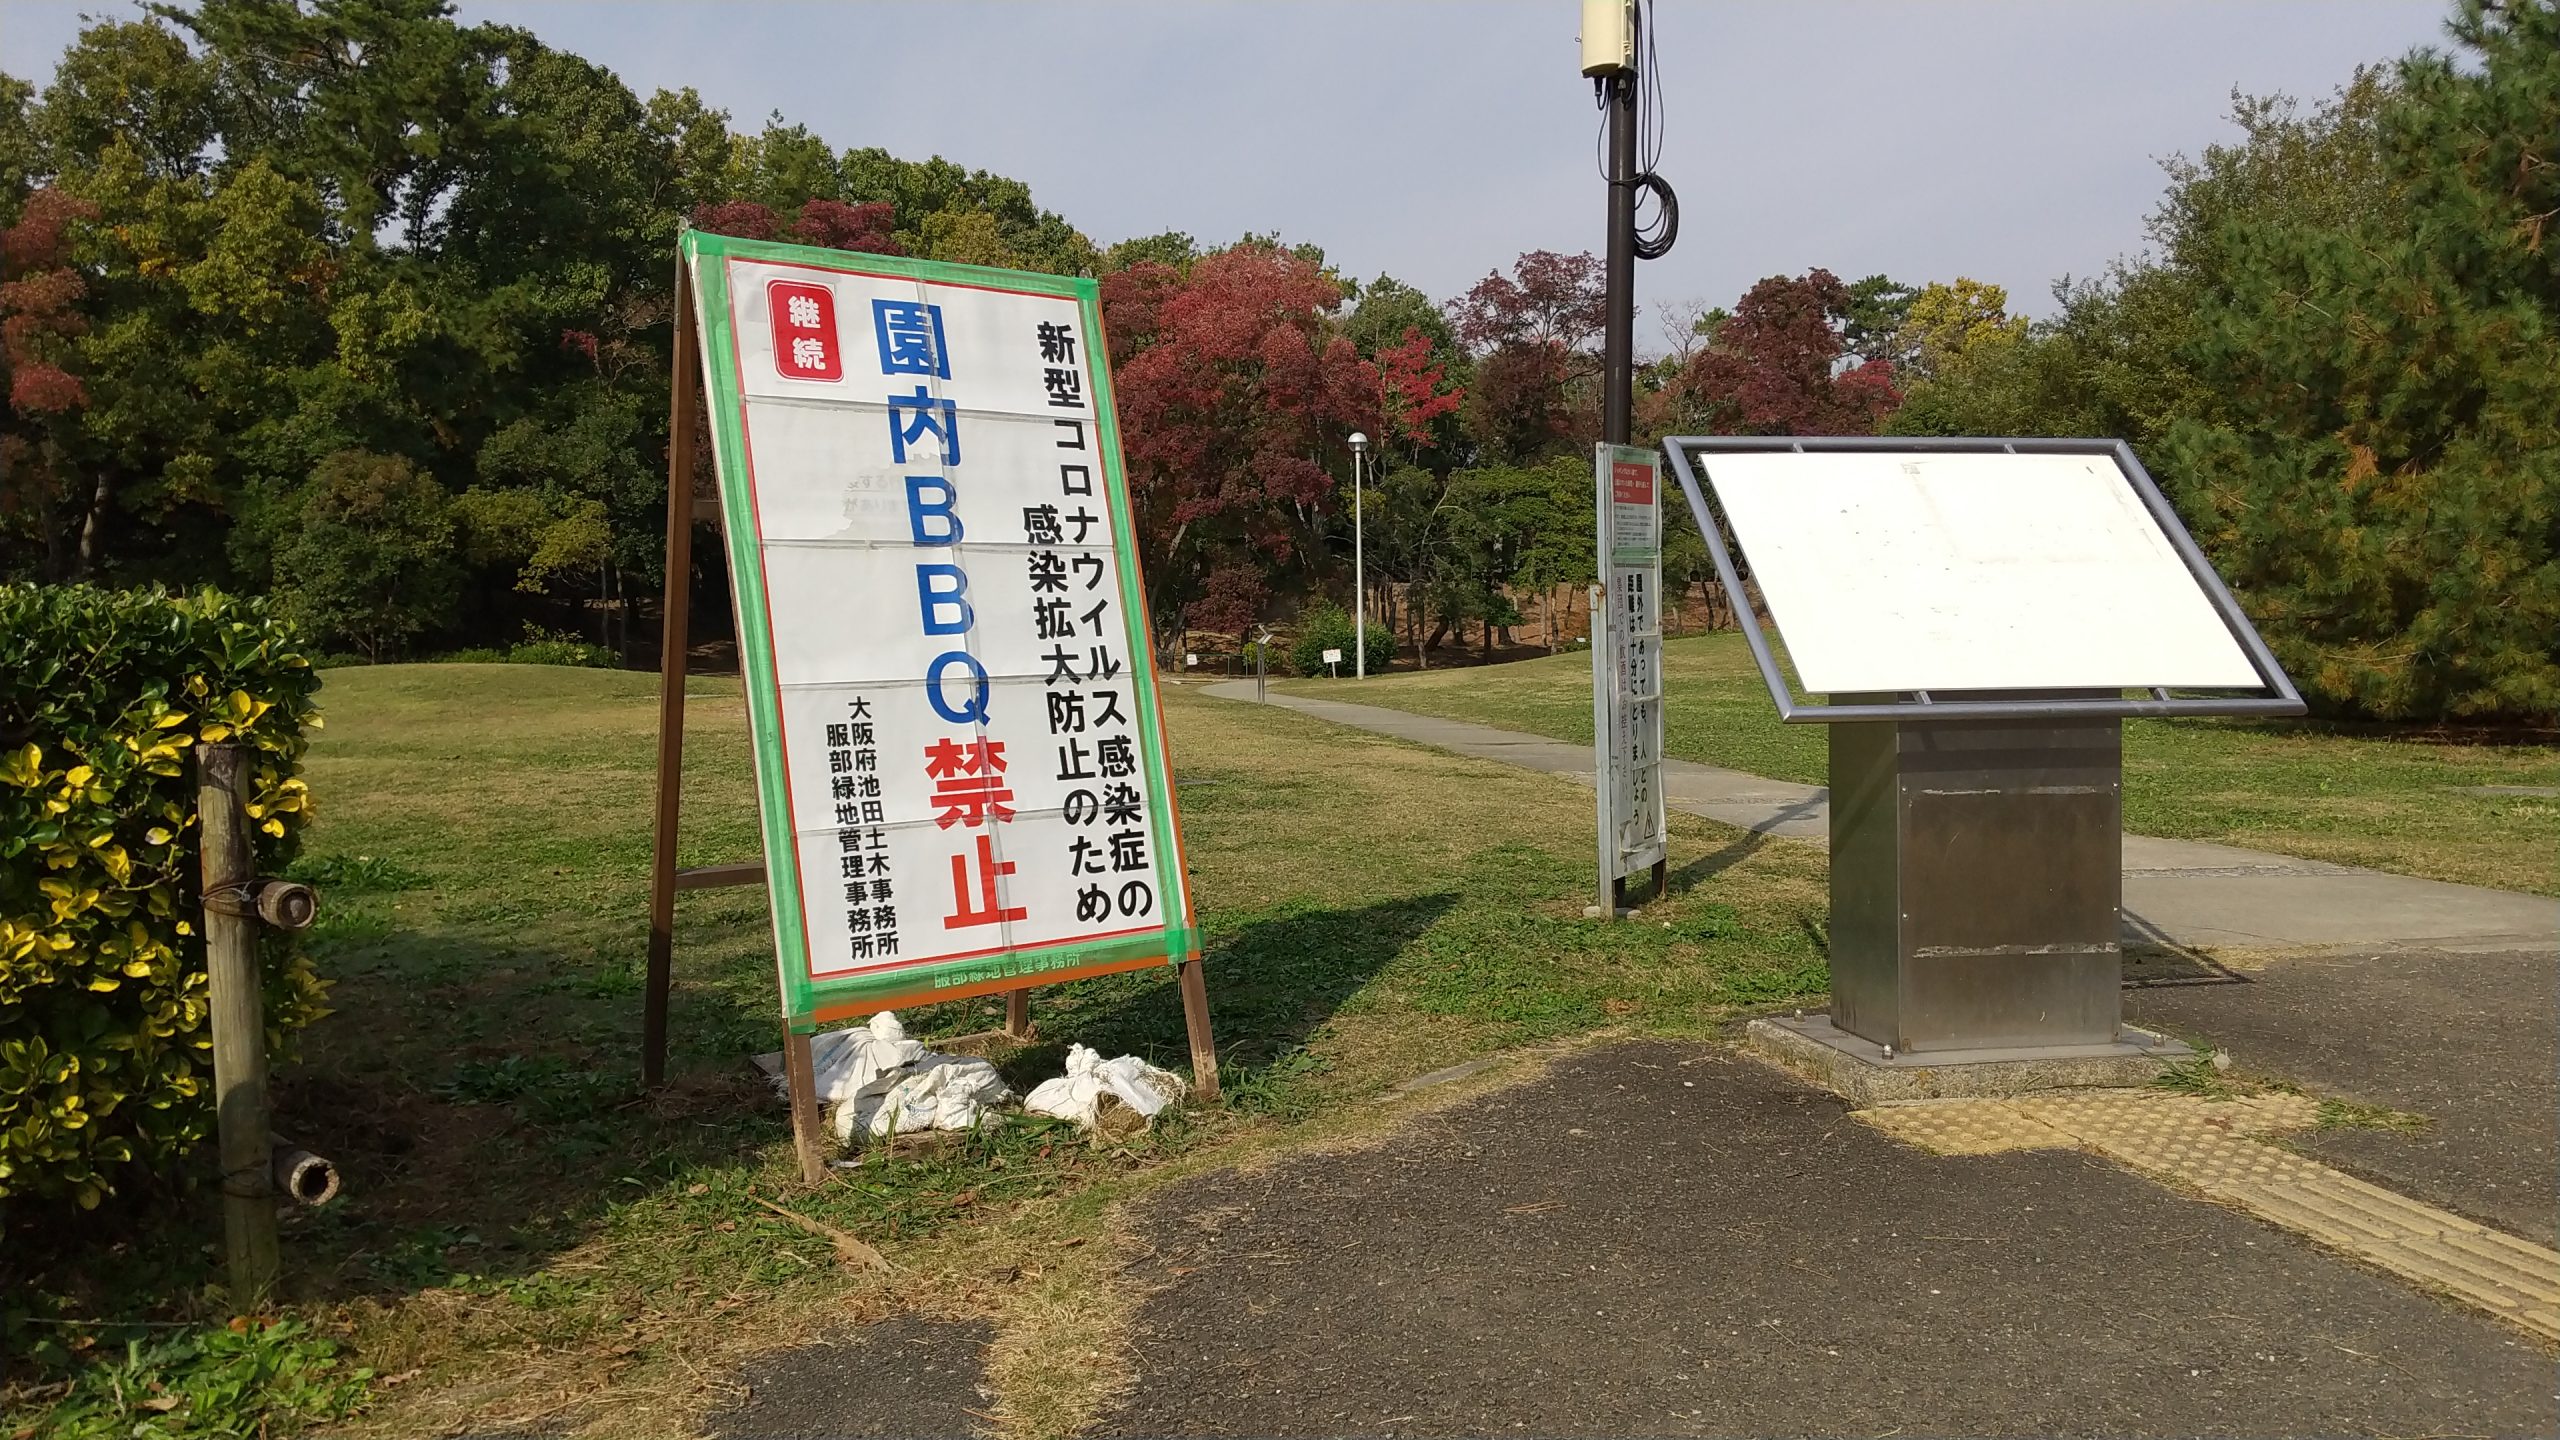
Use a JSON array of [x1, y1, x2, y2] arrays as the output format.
[[1285, 633, 2560, 894]]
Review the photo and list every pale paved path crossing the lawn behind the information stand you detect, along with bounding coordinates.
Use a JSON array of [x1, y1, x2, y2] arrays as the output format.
[[1203, 682, 2560, 951]]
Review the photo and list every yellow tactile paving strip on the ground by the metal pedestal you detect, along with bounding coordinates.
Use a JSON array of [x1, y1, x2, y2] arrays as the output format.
[[1859, 1089, 2560, 1340]]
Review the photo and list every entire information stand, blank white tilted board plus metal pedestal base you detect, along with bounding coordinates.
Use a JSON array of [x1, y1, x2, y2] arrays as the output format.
[[1664, 436, 2304, 1063]]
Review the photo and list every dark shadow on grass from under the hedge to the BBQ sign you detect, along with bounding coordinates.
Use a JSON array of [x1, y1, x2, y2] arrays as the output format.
[[0, 912, 788, 1343]]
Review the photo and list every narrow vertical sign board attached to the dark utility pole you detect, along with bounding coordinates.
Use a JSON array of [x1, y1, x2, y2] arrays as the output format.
[[1592, 443, 1669, 907]]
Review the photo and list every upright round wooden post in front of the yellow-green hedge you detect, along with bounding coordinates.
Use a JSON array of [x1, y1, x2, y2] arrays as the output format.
[[195, 746, 276, 1312]]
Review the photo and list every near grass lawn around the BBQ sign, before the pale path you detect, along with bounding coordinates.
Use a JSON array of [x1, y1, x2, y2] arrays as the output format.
[[0, 666, 1825, 1437]]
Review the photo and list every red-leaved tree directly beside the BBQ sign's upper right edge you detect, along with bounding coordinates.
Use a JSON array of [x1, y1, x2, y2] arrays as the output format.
[[1103, 243, 1382, 646]]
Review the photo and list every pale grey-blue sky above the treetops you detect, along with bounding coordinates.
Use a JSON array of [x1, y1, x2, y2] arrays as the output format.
[[0, 0, 2445, 338]]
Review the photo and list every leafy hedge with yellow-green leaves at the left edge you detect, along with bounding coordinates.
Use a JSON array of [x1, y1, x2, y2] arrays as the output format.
[[0, 584, 323, 1207]]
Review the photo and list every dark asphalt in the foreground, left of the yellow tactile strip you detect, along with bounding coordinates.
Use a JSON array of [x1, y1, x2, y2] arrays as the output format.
[[1098, 1043, 2560, 1435]]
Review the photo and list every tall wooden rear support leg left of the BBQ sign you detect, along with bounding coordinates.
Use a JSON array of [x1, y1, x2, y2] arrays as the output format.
[[640, 259, 706, 1084]]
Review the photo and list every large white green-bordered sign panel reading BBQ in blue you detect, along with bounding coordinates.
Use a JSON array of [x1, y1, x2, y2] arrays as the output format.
[[684, 231, 1198, 1022]]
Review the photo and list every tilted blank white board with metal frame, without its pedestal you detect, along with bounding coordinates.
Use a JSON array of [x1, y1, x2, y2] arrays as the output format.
[[1664, 436, 2301, 725]]
